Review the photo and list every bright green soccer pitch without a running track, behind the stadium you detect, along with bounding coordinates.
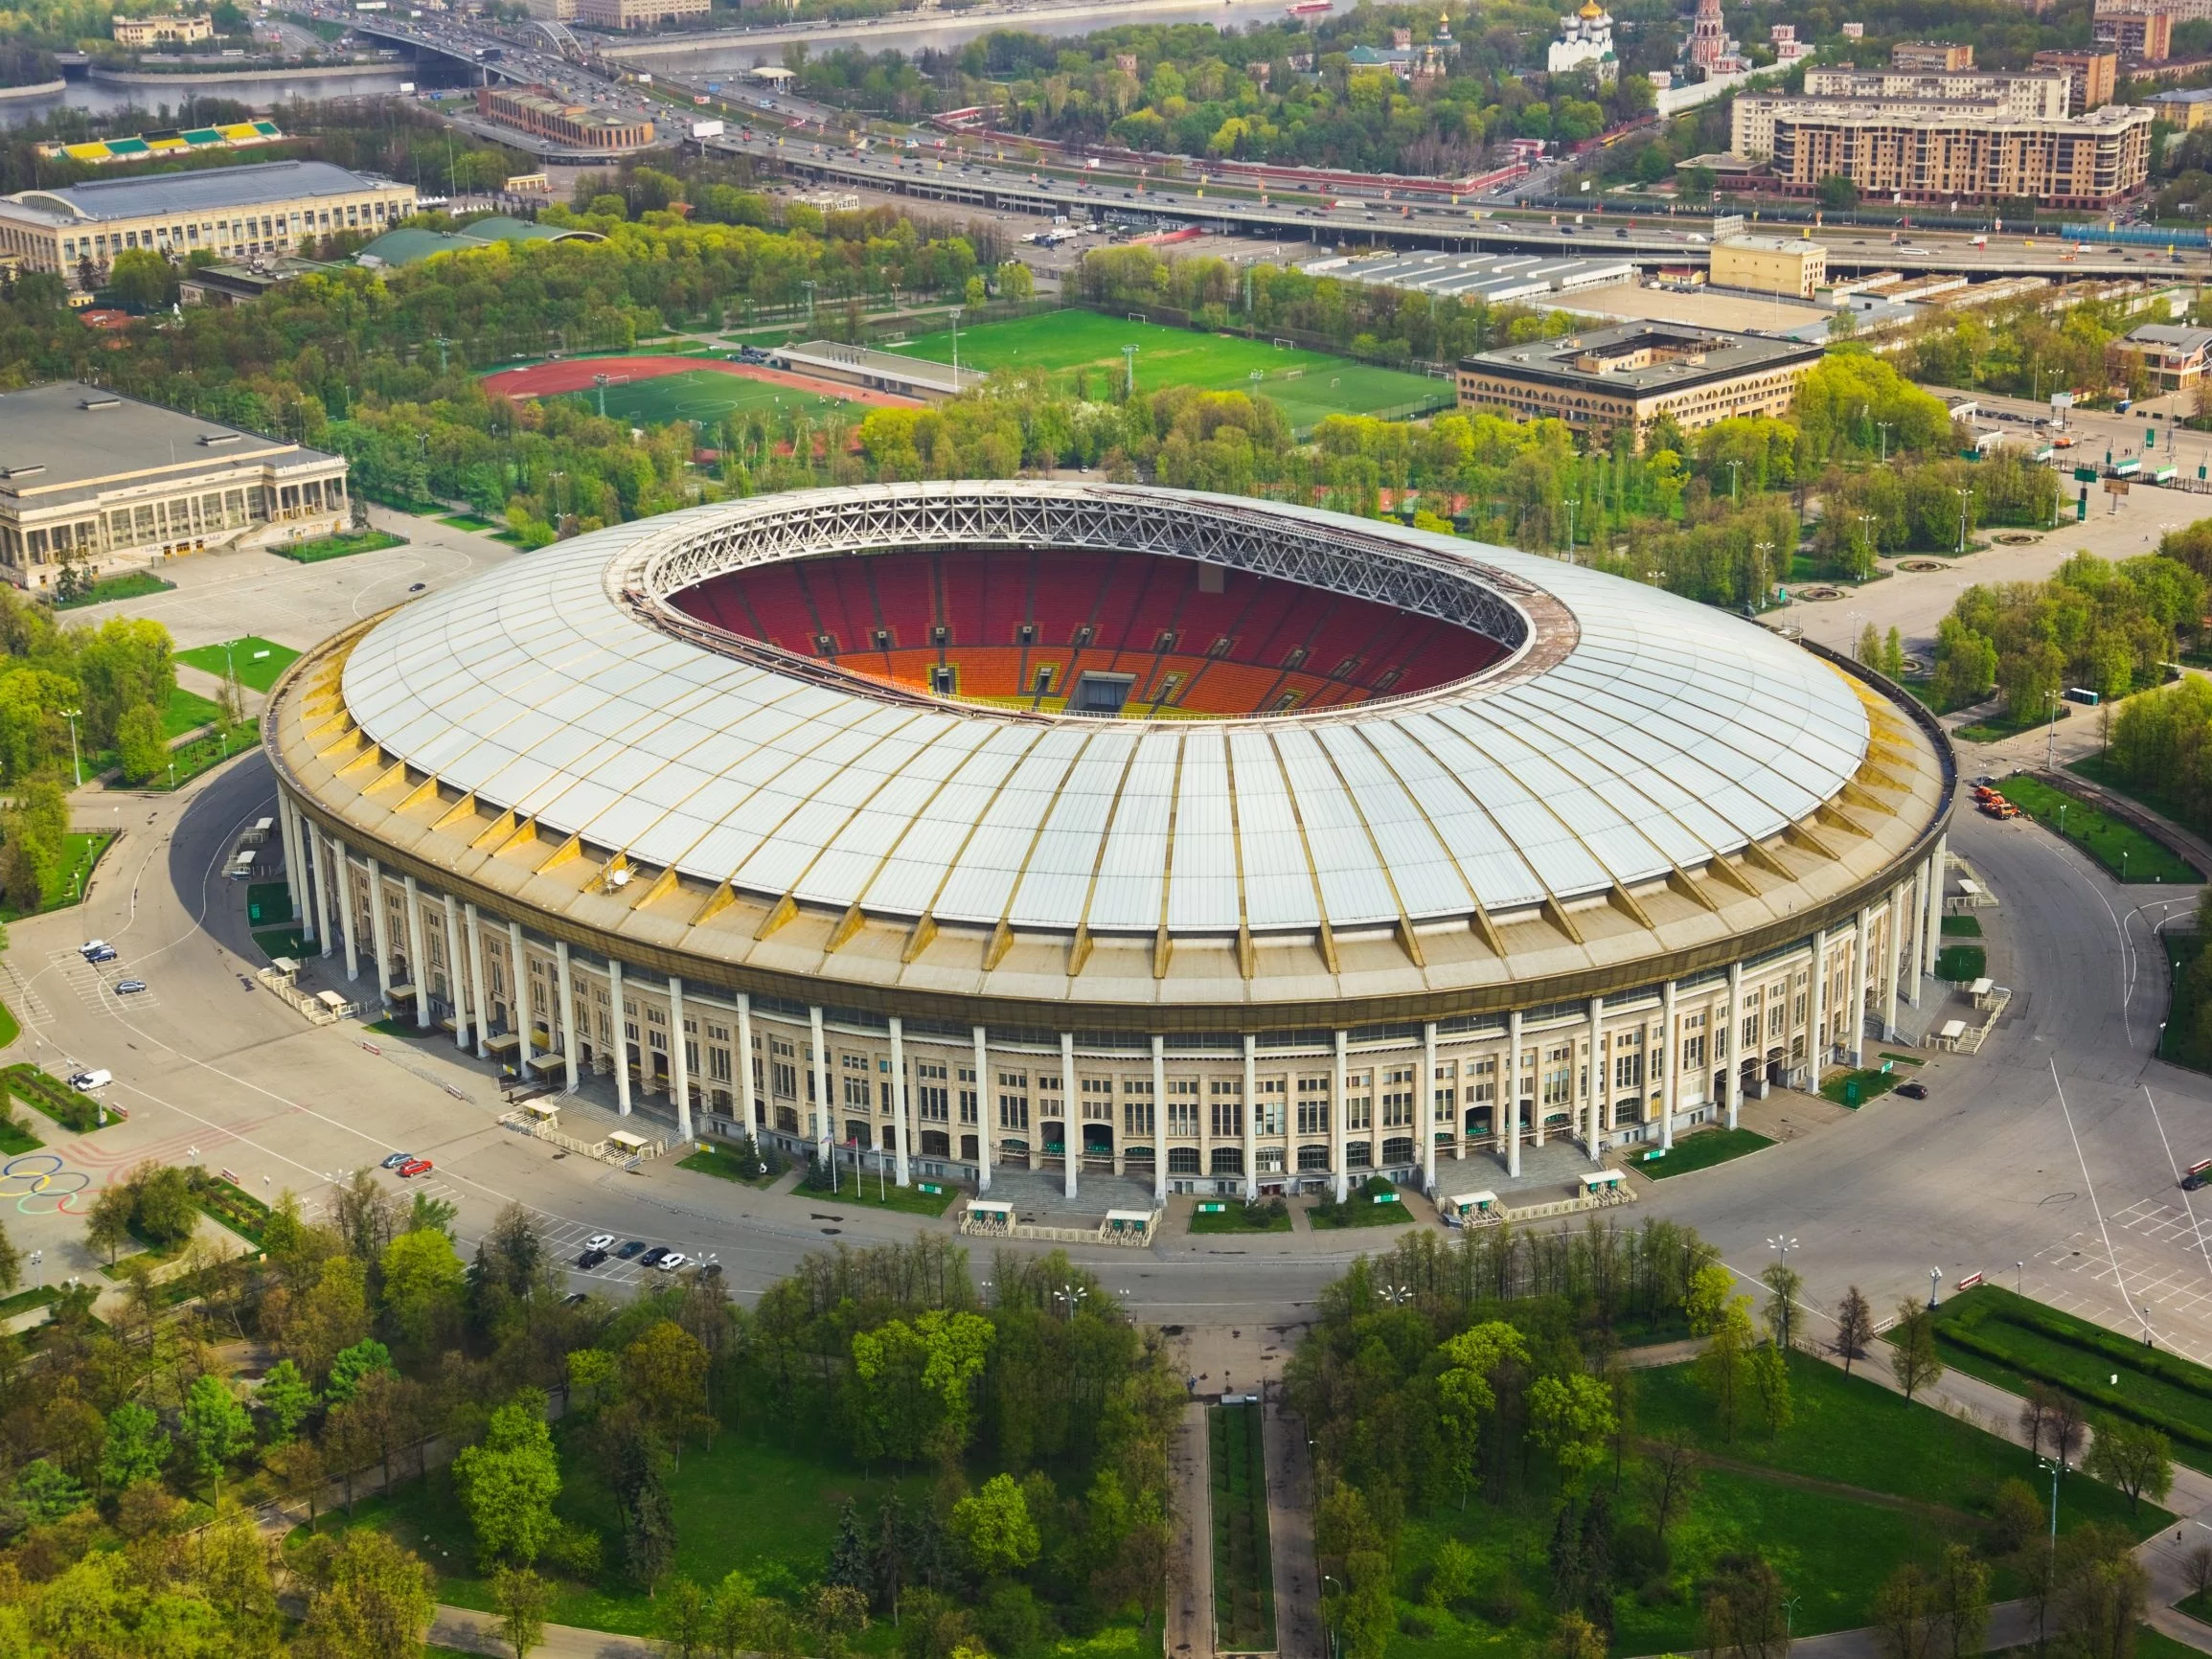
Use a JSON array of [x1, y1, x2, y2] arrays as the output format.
[[885, 309, 1453, 429]]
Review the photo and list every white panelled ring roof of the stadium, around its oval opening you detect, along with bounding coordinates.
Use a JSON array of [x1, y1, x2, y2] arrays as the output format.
[[343, 482, 1871, 936]]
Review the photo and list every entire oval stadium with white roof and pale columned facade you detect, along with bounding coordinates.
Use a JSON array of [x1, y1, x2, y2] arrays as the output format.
[[263, 482, 1955, 1208]]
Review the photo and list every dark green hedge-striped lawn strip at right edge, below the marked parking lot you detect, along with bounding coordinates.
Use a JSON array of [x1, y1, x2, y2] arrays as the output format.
[[1935, 1285, 2212, 1473]]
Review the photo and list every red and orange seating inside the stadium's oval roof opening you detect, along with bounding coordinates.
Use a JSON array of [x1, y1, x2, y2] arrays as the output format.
[[674, 549, 1497, 715]]
